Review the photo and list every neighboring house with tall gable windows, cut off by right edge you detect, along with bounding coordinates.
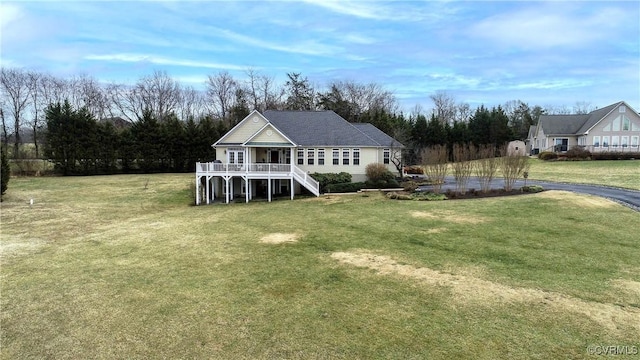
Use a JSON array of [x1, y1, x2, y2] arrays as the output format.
[[528, 101, 640, 154]]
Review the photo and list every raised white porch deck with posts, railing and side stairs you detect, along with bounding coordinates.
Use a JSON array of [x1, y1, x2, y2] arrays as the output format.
[[195, 147, 320, 205]]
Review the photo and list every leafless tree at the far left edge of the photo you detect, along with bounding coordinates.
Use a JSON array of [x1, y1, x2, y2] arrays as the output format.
[[0, 68, 31, 157]]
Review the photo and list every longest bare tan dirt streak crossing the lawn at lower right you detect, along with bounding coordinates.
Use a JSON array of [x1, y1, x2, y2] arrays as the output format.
[[331, 252, 640, 334]]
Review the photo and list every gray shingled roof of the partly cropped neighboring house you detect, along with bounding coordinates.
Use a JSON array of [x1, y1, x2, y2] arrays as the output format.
[[538, 102, 622, 135]]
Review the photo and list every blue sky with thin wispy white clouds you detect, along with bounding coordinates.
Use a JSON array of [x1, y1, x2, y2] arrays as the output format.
[[0, 0, 640, 111]]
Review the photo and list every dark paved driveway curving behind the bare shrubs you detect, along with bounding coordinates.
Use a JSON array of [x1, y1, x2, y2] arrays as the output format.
[[421, 176, 640, 211]]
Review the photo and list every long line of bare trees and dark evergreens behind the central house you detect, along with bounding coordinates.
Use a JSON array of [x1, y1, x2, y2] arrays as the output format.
[[0, 68, 593, 173]]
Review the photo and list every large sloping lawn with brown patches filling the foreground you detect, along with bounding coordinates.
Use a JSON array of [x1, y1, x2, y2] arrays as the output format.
[[0, 173, 640, 359]]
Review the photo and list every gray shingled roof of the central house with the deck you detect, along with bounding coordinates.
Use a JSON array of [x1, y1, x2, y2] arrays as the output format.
[[263, 110, 400, 147]]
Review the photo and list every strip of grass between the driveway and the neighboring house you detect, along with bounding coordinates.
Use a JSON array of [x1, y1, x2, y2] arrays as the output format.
[[529, 158, 640, 190]]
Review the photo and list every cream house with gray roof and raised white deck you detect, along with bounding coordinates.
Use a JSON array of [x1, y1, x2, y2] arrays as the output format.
[[196, 110, 404, 205]]
